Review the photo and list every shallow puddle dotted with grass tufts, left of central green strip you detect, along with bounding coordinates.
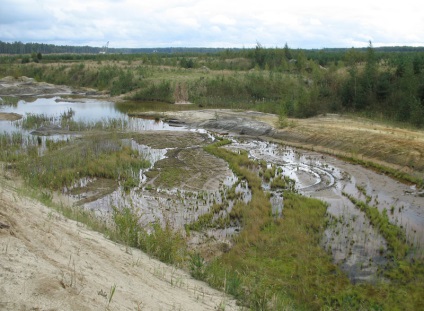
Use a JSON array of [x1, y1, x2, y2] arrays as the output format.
[[83, 174, 251, 238]]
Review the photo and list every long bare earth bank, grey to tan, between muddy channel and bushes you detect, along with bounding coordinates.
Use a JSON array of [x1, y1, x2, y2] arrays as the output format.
[[158, 110, 424, 179]]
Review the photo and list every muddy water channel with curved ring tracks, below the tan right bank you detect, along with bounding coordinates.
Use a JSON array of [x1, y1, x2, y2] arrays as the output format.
[[230, 141, 424, 281]]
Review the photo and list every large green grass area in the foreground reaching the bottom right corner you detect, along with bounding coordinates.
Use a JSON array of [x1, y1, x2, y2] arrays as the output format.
[[201, 141, 424, 310]]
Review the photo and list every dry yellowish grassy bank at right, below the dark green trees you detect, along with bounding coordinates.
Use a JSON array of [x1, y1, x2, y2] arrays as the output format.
[[275, 115, 424, 178]]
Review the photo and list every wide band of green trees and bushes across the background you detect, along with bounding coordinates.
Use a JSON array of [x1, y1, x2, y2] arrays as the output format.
[[0, 42, 424, 127]]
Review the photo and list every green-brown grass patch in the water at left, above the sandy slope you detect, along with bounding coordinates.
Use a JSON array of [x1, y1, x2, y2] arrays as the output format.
[[18, 134, 150, 190]]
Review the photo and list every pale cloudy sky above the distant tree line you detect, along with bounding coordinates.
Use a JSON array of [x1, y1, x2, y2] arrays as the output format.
[[0, 0, 424, 49]]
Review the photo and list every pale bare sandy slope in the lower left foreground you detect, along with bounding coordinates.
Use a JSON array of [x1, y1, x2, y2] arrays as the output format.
[[0, 176, 236, 310]]
